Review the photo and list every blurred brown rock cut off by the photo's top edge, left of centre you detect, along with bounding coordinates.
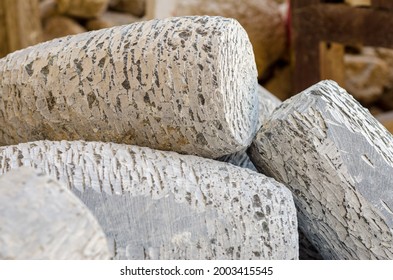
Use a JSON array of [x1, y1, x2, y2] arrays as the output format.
[[56, 0, 109, 18]]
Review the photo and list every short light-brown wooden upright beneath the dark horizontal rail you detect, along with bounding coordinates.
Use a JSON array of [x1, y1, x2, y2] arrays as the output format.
[[319, 42, 345, 86]]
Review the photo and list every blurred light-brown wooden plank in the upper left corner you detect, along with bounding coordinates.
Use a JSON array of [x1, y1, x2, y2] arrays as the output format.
[[0, 0, 42, 57]]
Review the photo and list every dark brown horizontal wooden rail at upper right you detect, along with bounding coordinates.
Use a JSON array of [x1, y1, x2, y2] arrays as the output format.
[[293, 4, 393, 48]]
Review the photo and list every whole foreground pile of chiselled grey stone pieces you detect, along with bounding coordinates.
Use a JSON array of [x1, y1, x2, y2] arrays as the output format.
[[0, 15, 393, 259]]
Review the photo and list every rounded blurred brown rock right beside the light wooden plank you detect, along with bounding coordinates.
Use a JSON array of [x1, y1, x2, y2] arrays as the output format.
[[44, 16, 87, 41]]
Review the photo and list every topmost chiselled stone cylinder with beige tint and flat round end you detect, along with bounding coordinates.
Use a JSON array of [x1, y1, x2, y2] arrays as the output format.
[[0, 16, 258, 158]]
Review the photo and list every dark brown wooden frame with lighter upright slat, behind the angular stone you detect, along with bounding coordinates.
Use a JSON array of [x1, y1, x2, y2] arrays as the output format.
[[291, 0, 393, 92]]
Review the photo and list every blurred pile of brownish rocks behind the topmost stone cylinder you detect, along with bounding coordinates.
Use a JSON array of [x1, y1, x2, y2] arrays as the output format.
[[40, 0, 291, 100]]
